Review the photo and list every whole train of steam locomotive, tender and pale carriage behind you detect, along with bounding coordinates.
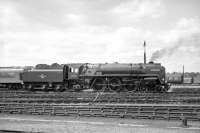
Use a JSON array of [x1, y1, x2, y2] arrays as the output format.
[[0, 62, 167, 92]]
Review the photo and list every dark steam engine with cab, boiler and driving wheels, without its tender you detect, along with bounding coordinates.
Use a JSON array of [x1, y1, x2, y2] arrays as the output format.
[[64, 62, 166, 92]]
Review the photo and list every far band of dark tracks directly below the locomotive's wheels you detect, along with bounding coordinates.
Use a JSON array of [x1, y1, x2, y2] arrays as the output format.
[[0, 92, 200, 104]]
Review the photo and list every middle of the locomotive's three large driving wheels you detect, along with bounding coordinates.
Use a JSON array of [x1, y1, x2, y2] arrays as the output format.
[[109, 78, 122, 91]]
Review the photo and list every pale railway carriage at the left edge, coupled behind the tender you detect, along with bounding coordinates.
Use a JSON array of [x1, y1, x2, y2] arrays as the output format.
[[0, 67, 23, 89]]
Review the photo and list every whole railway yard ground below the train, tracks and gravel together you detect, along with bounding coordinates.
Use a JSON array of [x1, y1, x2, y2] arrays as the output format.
[[0, 89, 200, 133]]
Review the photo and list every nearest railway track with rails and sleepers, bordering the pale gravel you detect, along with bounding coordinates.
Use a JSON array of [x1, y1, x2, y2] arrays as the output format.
[[0, 103, 200, 121]]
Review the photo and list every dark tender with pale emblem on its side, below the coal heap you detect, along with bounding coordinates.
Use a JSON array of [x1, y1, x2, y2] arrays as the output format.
[[22, 69, 63, 91]]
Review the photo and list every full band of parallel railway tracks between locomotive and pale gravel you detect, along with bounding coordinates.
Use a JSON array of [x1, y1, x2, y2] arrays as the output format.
[[0, 91, 200, 121]]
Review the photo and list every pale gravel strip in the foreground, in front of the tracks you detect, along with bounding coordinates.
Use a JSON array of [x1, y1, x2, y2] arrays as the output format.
[[0, 114, 200, 133]]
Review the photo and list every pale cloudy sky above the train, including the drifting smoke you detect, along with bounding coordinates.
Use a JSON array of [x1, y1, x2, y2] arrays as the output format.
[[0, 0, 200, 72]]
